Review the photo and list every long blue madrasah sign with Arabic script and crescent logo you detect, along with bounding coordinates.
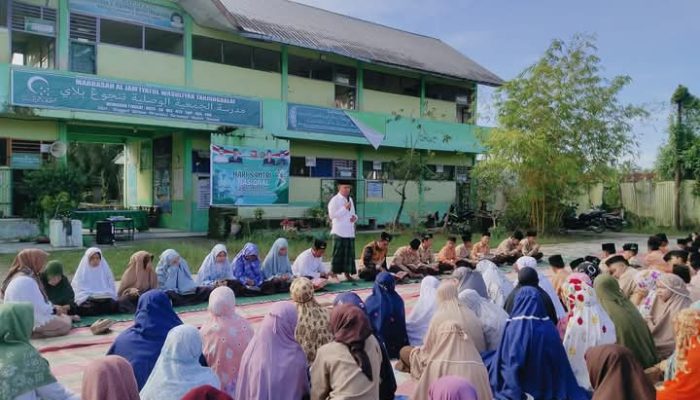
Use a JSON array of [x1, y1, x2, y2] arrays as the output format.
[[11, 69, 262, 127]]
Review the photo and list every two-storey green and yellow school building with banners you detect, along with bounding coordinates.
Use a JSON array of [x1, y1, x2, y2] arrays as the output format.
[[0, 0, 502, 231]]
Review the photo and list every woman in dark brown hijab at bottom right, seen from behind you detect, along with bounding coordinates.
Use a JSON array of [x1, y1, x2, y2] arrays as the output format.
[[585, 344, 656, 400]]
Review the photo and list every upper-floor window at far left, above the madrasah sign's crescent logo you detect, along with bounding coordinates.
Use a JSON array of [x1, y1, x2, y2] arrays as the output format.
[[12, 31, 56, 69]]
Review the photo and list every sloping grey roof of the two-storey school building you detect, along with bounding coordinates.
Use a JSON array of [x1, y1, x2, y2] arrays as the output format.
[[179, 0, 503, 86]]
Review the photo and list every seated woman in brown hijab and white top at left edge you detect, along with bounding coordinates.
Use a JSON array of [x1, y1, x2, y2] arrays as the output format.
[[2, 249, 73, 338]]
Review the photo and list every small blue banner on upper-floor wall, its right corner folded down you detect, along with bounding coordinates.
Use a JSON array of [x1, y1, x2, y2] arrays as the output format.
[[287, 104, 364, 137]]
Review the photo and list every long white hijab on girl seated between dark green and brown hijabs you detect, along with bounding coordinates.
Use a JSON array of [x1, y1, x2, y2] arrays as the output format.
[[71, 247, 117, 305]]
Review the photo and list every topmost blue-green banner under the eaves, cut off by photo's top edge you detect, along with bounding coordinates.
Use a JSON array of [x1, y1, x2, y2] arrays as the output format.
[[70, 0, 185, 31]]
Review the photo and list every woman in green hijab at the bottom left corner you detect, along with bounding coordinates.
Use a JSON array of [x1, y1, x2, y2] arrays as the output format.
[[0, 303, 78, 400]]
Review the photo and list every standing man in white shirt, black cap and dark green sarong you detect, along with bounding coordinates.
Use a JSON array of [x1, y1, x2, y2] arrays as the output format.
[[328, 181, 357, 282]]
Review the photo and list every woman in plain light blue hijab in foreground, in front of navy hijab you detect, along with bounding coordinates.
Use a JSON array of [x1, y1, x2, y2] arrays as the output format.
[[140, 325, 221, 400]]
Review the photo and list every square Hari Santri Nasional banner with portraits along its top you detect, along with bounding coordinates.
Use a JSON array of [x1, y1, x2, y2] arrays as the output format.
[[211, 144, 289, 206]]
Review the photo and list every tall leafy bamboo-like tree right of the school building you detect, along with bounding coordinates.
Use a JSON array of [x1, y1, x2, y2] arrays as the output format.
[[475, 35, 646, 232]]
